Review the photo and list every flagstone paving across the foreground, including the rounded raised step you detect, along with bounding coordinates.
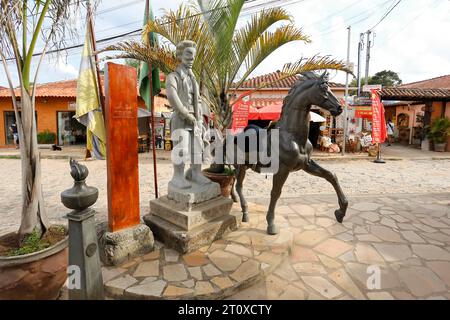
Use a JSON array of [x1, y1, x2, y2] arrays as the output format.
[[103, 193, 450, 300]]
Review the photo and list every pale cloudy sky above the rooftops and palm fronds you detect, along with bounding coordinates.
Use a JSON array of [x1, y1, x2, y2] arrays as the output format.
[[0, 0, 450, 86]]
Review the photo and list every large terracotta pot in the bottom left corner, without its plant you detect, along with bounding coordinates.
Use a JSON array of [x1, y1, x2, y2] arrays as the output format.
[[0, 236, 69, 300]]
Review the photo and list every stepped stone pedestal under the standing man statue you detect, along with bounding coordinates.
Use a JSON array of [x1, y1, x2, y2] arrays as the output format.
[[144, 183, 242, 253]]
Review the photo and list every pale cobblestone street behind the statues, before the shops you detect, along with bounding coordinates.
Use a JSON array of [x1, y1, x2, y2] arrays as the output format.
[[0, 159, 450, 233]]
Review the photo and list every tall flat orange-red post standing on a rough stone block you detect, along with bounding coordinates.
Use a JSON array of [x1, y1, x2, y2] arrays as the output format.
[[105, 63, 140, 232]]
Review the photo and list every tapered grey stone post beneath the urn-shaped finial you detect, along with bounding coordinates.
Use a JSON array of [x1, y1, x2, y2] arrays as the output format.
[[67, 209, 103, 300]]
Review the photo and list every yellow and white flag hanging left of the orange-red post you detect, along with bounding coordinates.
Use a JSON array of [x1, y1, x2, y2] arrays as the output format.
[[75, 22, 106, 160]]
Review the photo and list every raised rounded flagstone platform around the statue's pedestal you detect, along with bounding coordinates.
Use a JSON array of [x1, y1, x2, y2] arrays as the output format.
[[103, 204, 294, 300]]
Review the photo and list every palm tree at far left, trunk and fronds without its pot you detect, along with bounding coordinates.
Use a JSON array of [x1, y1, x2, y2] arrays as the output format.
[[0, 0, 93, 242]]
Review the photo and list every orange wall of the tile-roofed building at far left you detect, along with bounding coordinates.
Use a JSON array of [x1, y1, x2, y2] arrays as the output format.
[[0, 98, 75, 147]]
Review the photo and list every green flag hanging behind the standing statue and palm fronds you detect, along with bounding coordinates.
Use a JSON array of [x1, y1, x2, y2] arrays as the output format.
[[139, 1, 161, 110]]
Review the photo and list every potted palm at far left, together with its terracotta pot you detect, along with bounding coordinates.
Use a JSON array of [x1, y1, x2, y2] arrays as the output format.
[[0, 0, 90, 300]]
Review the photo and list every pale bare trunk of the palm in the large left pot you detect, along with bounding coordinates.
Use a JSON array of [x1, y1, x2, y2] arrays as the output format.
[[16, 87, 49, 243]]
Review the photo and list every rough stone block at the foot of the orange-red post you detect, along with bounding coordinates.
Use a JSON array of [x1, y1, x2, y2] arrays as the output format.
[[99, 224, 154, 266]]
